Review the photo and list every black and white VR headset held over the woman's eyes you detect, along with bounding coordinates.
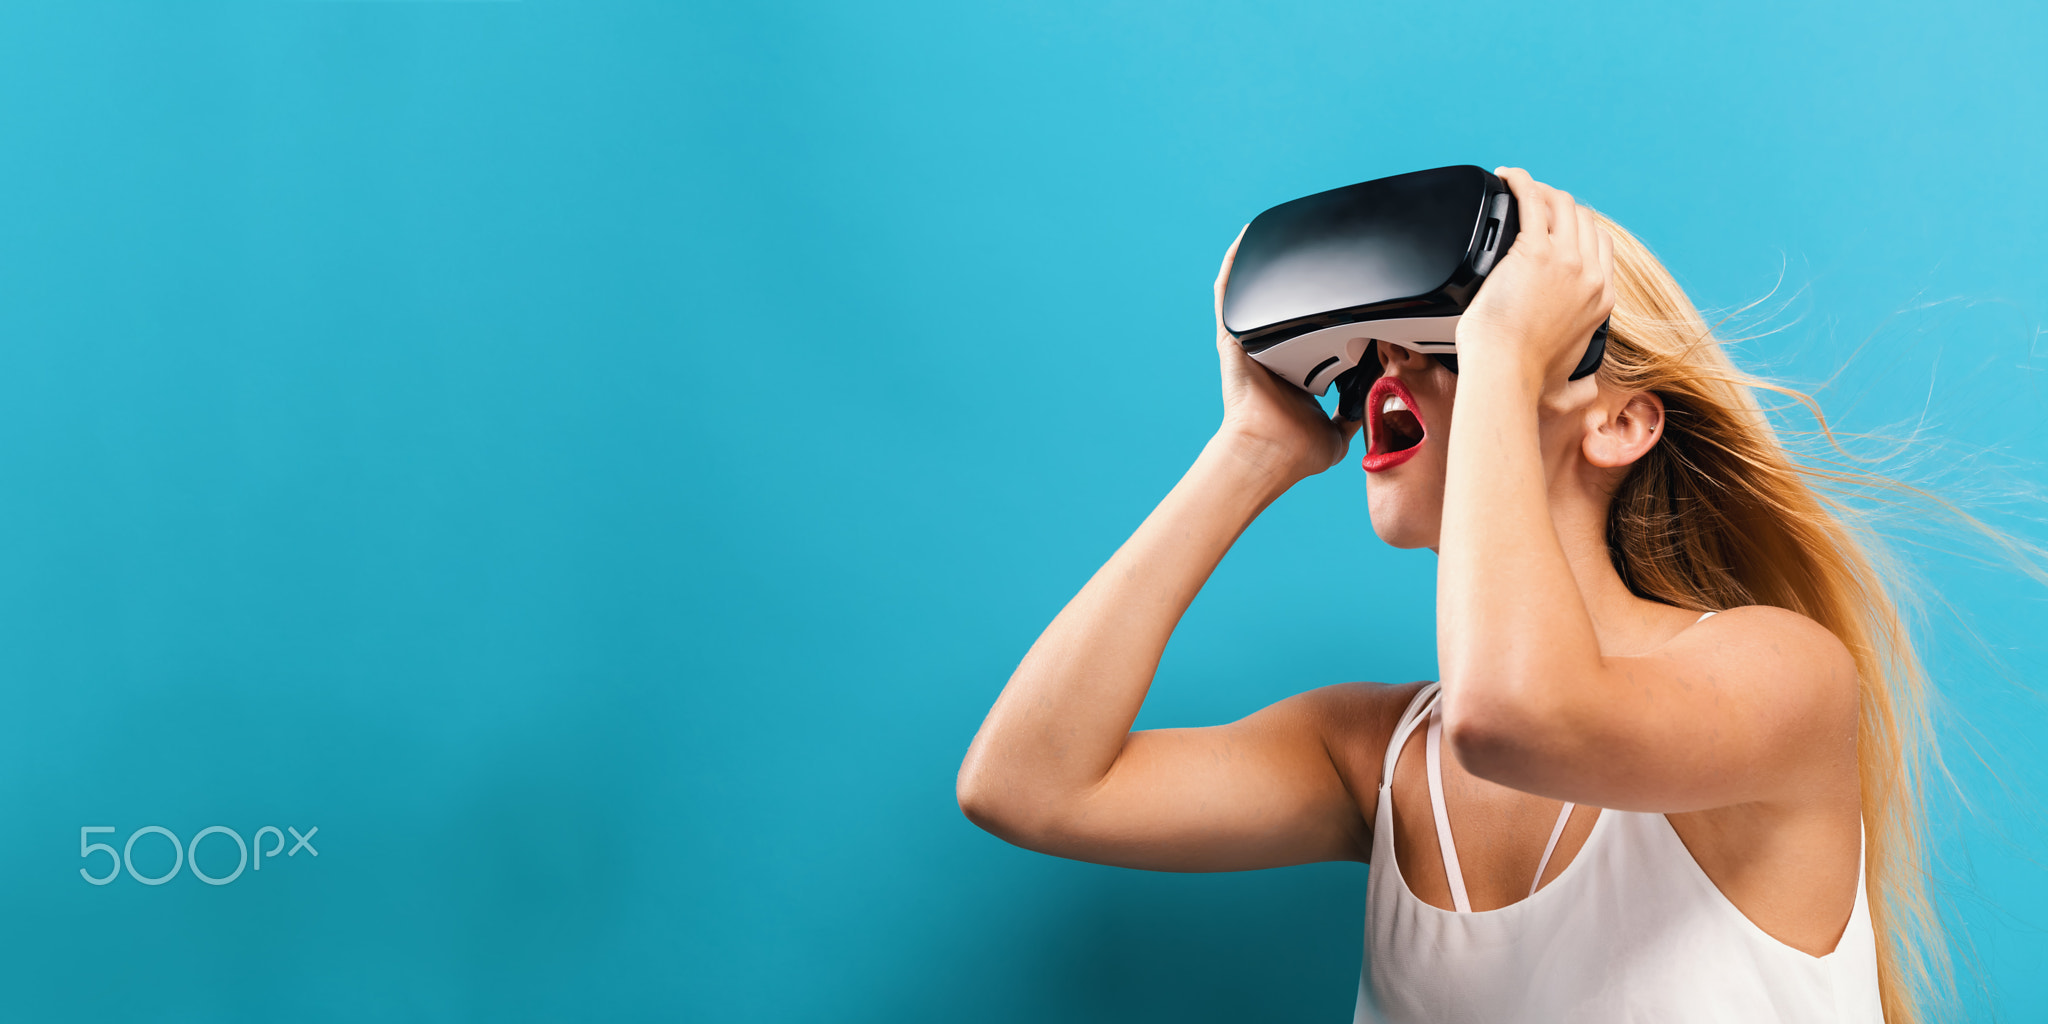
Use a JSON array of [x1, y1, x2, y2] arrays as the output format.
[[1223, 164, 1608, 420]]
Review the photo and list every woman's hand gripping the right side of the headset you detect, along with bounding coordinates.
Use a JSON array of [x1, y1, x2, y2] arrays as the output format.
[[1458, 168, 1614, 393]]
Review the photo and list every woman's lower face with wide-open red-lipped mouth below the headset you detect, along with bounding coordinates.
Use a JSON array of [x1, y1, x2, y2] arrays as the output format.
[[1362, 342, 1458, 549]]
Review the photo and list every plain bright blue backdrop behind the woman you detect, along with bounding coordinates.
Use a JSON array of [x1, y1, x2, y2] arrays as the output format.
[[0, 2, 2048, 1022]]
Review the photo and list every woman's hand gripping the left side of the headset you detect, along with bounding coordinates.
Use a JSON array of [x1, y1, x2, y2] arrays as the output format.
[[1217, 231, 1360, 483]]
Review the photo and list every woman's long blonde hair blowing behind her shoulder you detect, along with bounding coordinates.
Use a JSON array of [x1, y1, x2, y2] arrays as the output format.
[[1599, 217, 1993, 1024]]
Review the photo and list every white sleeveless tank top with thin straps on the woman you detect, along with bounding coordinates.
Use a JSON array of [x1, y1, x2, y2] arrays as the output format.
[[1354, 612, 1884, 1024]]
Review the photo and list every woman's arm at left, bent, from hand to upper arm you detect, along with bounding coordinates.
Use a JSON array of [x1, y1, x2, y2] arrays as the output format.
[[958, 232, 1386, 870]]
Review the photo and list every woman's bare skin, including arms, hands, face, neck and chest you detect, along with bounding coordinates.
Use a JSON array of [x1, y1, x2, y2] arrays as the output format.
[[958, 168, 1860, 956]]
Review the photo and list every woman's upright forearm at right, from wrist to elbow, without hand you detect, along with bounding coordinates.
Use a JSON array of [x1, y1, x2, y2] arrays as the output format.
[[1438, 365, 1599, 737]]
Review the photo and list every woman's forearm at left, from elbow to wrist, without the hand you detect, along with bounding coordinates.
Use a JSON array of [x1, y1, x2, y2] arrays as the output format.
[[958, 434, 1292, 831]]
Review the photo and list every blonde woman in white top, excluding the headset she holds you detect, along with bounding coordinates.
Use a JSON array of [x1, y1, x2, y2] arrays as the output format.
[[958, 170, 1933, 1024]]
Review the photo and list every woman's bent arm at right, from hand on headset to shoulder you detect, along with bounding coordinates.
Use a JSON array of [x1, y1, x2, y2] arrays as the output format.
[[1438, 170, 1855, 811]]
